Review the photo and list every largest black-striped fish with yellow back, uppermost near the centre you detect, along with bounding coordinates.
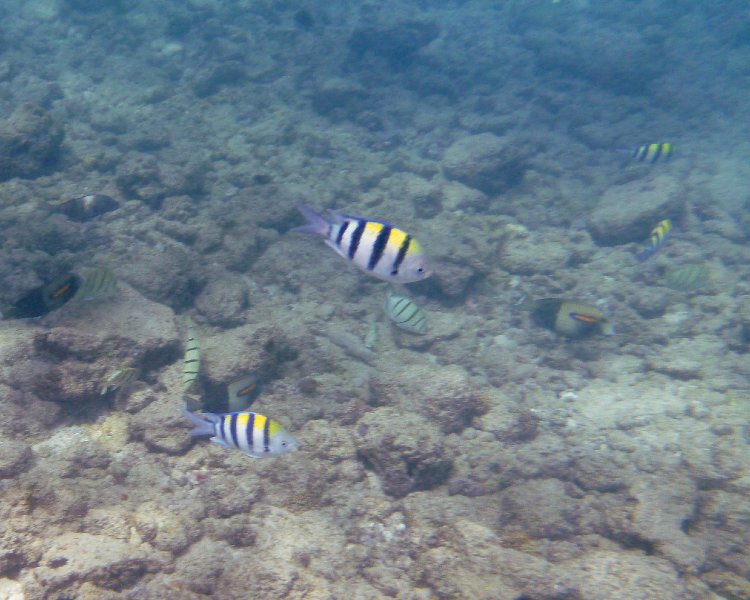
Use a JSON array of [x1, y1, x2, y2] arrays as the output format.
[[293, 204, 432, 283]]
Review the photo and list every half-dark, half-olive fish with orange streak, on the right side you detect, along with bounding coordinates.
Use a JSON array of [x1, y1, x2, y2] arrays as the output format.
[[531, 298, 615, 338]]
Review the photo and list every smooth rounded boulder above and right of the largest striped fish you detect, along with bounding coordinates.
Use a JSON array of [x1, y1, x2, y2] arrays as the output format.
[[443, 133, 529, 196]]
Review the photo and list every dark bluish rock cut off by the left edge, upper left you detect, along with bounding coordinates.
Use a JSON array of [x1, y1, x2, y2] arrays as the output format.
[[0, 104, 65, 181]]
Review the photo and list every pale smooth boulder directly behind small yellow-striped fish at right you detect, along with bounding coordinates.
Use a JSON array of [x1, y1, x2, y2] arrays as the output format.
[[588, 175, 685, 246]]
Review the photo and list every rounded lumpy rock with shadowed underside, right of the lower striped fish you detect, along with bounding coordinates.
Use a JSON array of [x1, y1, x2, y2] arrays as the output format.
[[355, 407, 452, 497]]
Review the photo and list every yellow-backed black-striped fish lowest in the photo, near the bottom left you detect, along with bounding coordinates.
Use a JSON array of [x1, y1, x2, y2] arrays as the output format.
[[182, 410, 297, 458]]
